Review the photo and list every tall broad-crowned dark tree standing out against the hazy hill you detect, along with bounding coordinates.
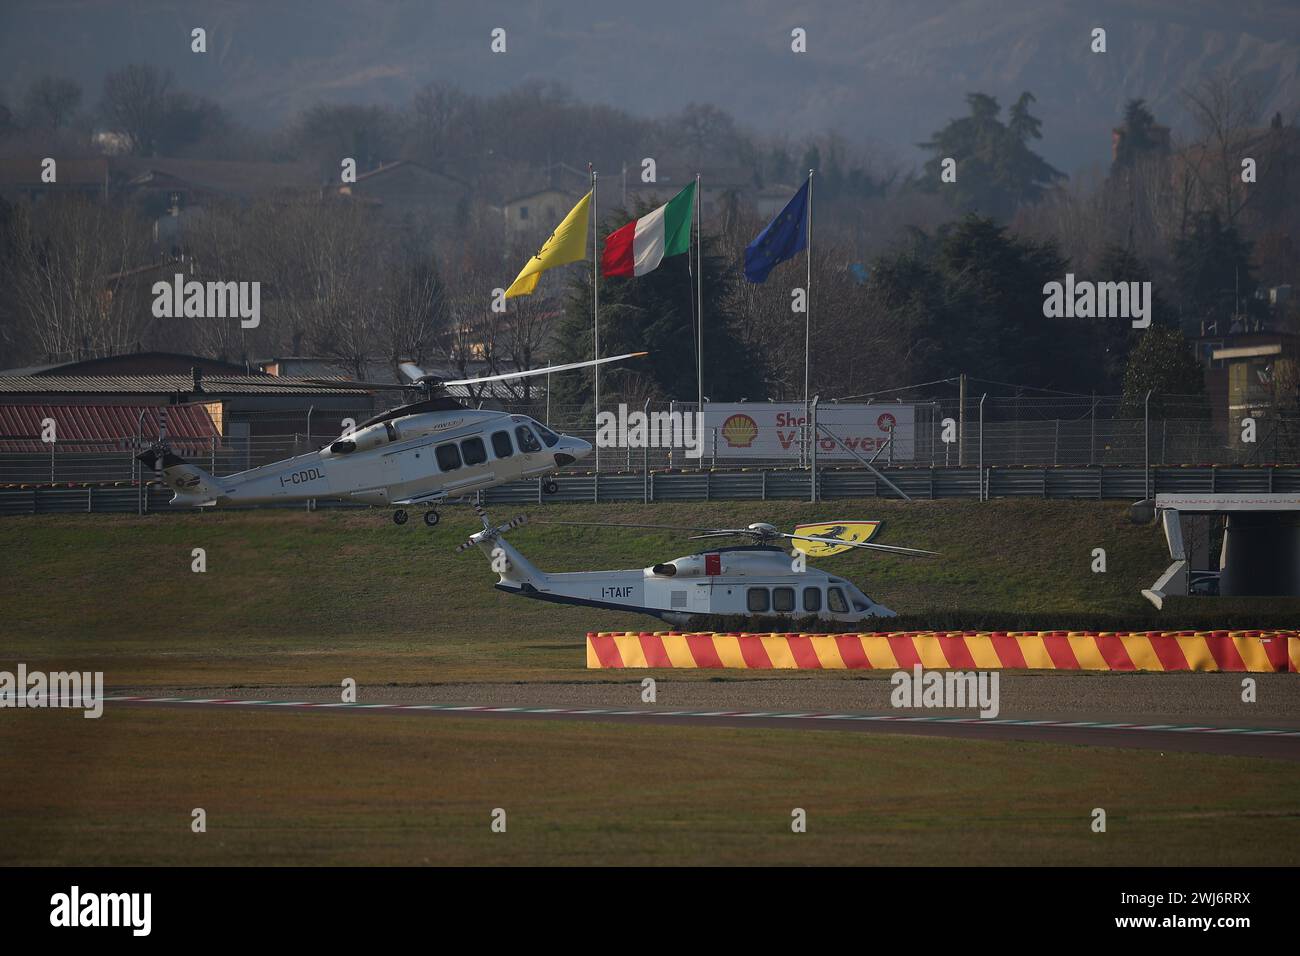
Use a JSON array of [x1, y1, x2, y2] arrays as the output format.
[[920, 92, 1065, 221]]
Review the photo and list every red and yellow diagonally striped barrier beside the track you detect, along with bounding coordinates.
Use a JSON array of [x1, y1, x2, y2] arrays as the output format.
[[586, 631, 1300, 671]]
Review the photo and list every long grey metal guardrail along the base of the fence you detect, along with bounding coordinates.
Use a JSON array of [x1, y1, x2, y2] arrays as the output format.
[[0, 466, 1300, 515]]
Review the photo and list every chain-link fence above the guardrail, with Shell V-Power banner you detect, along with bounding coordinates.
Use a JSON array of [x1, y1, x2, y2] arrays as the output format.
[[0, 395, 1300, 485]]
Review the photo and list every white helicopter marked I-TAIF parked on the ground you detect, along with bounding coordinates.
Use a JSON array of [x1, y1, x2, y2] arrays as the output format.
[[456, 507, 936, 626]]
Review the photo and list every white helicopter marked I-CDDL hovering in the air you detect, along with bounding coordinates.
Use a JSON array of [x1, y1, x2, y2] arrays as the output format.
[[137, 352, 647, 528]]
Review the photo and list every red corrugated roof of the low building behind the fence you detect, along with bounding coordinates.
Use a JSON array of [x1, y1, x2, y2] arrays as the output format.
[[0, 405, 220, 455]]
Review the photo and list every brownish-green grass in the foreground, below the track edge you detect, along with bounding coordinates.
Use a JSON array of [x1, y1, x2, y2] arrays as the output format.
[[0, 709, 1300, 866]]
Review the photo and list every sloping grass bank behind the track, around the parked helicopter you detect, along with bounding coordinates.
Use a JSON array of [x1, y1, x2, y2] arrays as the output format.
[[0, 499, 1190, 685]]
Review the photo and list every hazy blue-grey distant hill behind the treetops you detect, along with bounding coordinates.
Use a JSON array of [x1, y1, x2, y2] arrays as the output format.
[[0, 0, 1300, 172]]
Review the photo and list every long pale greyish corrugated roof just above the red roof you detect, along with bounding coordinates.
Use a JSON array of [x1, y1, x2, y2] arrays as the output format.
[[0, 375, 369, 398]]
